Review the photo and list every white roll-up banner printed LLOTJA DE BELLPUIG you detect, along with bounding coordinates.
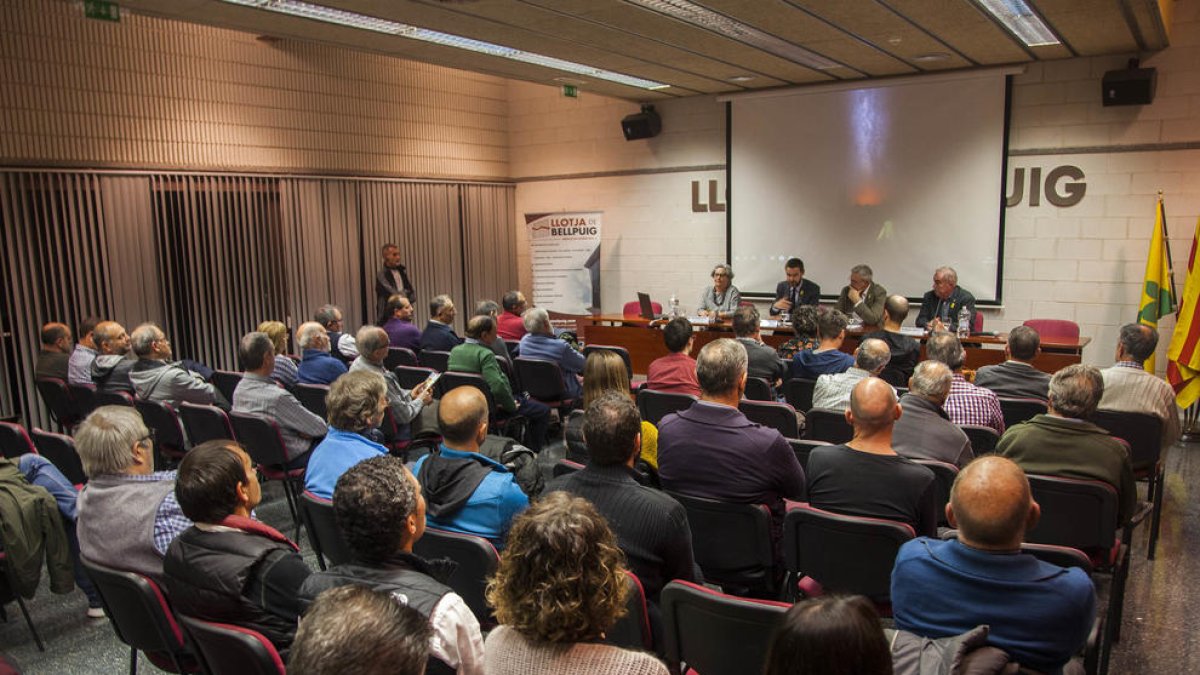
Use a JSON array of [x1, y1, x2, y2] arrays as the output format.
[[526, 211, 602, 315]]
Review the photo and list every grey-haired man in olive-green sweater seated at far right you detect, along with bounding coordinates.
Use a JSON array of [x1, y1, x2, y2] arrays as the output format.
[[996, 364, 1138, 522]]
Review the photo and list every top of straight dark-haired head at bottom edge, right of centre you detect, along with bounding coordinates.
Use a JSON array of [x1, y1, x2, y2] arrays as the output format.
[[763, 596, 892, 675]]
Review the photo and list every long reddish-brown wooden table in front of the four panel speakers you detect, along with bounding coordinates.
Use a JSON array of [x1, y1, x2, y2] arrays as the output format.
[[576, 315, 1092, 375]]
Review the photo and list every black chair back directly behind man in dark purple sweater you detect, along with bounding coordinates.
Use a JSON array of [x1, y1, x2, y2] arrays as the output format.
[[667, 490, 778, 596]]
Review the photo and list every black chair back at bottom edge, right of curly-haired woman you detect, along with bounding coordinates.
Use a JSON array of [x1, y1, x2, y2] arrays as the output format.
[[661, 580, 791, 675]]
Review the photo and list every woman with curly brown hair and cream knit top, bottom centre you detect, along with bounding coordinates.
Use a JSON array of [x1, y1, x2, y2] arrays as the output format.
[[484, 492, 667, 675]]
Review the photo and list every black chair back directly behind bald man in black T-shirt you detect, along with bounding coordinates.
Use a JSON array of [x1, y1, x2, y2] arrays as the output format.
[[784, 504, 916, 604]]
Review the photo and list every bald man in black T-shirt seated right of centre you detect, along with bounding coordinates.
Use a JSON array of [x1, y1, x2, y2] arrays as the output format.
[[808, 377, 937, 537]]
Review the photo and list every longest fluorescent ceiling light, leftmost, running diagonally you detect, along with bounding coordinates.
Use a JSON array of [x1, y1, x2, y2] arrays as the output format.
[[223, 0, 671, 89]]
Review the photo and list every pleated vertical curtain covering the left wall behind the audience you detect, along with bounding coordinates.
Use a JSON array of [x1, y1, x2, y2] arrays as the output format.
[[0, 169, 517, 426]]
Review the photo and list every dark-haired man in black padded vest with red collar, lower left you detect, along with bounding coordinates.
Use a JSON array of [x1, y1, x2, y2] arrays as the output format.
[[163, 440, 312, 659]]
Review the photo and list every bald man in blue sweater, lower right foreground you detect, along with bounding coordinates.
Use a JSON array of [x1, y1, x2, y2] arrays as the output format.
[[892, 455, 1096, 673]]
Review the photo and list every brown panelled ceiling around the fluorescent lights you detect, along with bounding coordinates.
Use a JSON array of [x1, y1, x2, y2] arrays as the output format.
[[120, 0, 1171, 101]]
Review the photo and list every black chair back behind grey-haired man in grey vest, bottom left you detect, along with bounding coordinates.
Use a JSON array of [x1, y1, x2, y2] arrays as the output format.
[[79, 557, 194, 671]]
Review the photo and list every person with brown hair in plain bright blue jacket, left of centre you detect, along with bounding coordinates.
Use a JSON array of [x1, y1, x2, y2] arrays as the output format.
[[304, 371, 388, 500]]
